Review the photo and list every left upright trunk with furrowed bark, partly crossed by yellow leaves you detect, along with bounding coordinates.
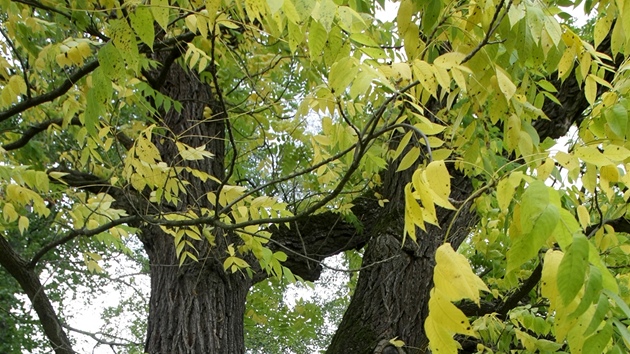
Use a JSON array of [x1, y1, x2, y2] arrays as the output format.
[[141, 53, 252, 354]]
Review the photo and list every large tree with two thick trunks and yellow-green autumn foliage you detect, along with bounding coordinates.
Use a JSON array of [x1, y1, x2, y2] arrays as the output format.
[[0, 0, 630, 354]]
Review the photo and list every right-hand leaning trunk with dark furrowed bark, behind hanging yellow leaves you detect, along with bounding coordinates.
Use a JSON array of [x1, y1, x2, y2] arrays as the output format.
[[327, 169, 475, 354]]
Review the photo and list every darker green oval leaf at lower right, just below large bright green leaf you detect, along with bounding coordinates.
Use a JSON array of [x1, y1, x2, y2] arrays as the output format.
[[558, 234, 589, 305]]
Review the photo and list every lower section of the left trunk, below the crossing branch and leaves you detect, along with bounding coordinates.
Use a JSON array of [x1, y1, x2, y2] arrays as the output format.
[[143, 227, 251, 354]]
